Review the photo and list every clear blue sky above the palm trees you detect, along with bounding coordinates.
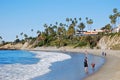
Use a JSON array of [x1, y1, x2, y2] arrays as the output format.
[[0, 0, 120, 41]]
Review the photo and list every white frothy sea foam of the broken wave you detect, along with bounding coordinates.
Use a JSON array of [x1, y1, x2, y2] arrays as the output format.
[[0, 51, 71, 80]]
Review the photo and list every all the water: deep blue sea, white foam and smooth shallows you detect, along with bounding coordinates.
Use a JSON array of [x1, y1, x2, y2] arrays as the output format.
[[0, 50, 104, 80]]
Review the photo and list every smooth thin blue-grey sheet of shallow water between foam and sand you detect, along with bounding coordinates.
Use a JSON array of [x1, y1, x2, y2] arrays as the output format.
[[33, 52, 105, 80]]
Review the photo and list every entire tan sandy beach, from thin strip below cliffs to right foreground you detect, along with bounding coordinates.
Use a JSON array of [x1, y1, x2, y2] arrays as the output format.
[[34, 47, 120, 80]]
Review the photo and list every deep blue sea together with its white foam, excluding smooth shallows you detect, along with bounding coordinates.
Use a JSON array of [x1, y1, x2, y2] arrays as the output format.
[[0, 50, 70, 80]]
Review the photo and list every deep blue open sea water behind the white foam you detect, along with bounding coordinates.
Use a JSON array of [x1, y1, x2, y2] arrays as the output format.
[[0, 50, 39, 65]]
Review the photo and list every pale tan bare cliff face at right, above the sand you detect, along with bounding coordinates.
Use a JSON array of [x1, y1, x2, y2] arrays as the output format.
[[97, 34, 120, 50]]
